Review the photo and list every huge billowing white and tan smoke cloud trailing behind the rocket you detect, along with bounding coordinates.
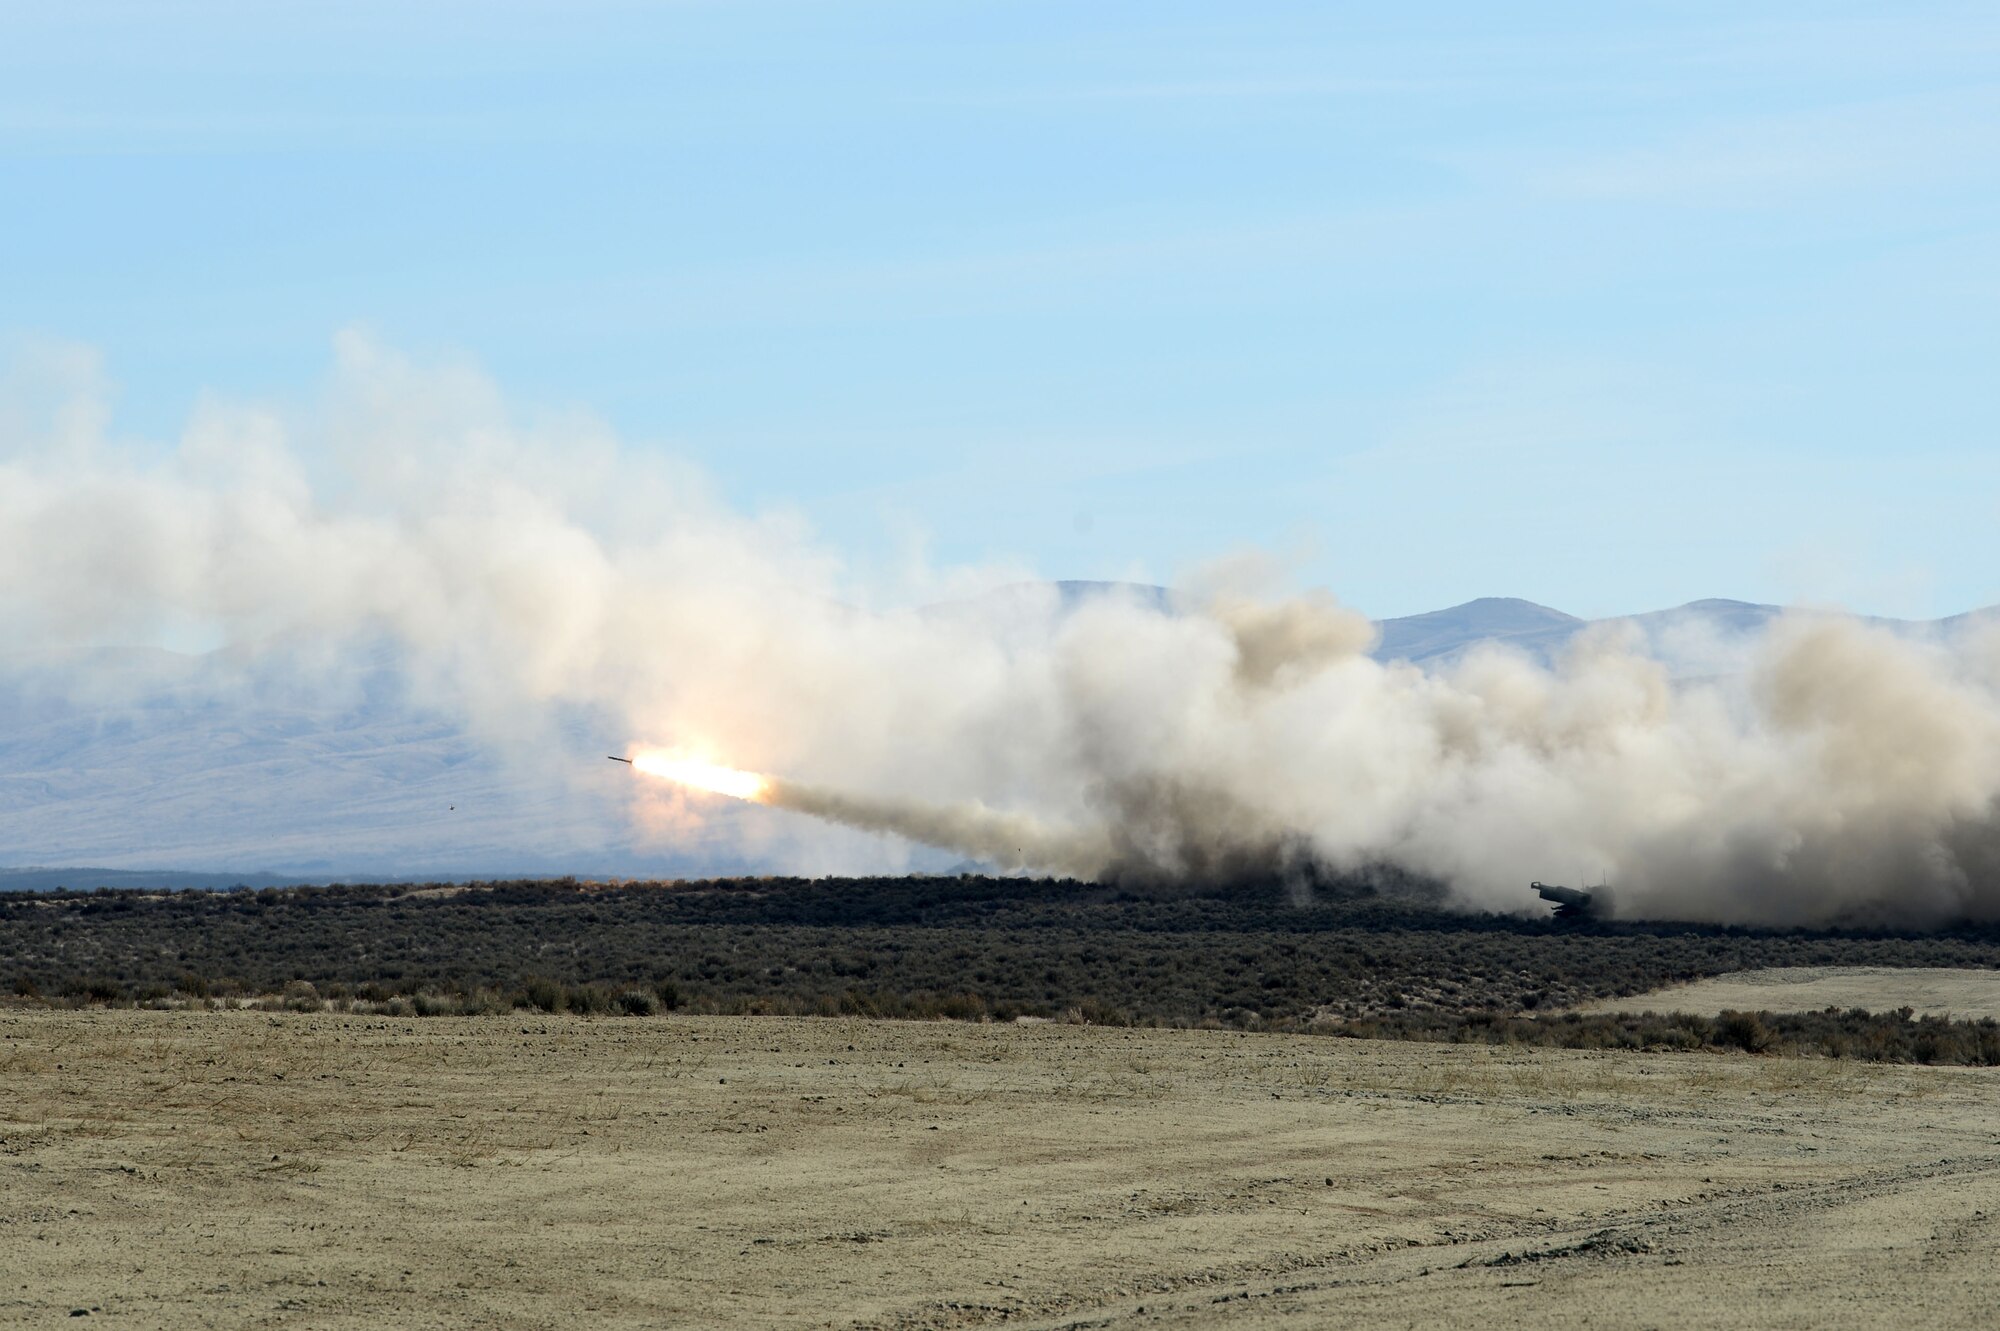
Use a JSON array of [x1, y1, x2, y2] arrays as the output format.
[[0, 336, 2000, 925]]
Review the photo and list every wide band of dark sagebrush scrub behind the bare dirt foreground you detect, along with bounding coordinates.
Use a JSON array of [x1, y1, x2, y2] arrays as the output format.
[[0, 875, 2000, 1031]]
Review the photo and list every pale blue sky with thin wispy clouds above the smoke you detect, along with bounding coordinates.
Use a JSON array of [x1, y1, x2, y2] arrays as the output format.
[[0, 0, 2000, 616]]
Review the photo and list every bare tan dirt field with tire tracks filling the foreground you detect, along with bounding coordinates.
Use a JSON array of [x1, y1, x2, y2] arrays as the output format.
[[0, 1009, 2000, 1327]]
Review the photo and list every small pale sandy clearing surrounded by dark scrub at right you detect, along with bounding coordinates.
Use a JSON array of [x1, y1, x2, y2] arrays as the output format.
[[1576, 965, 2000, 1019]]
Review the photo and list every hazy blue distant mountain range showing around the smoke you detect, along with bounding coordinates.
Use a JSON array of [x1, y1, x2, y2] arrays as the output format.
[[0, 582, 1970, 889]]
